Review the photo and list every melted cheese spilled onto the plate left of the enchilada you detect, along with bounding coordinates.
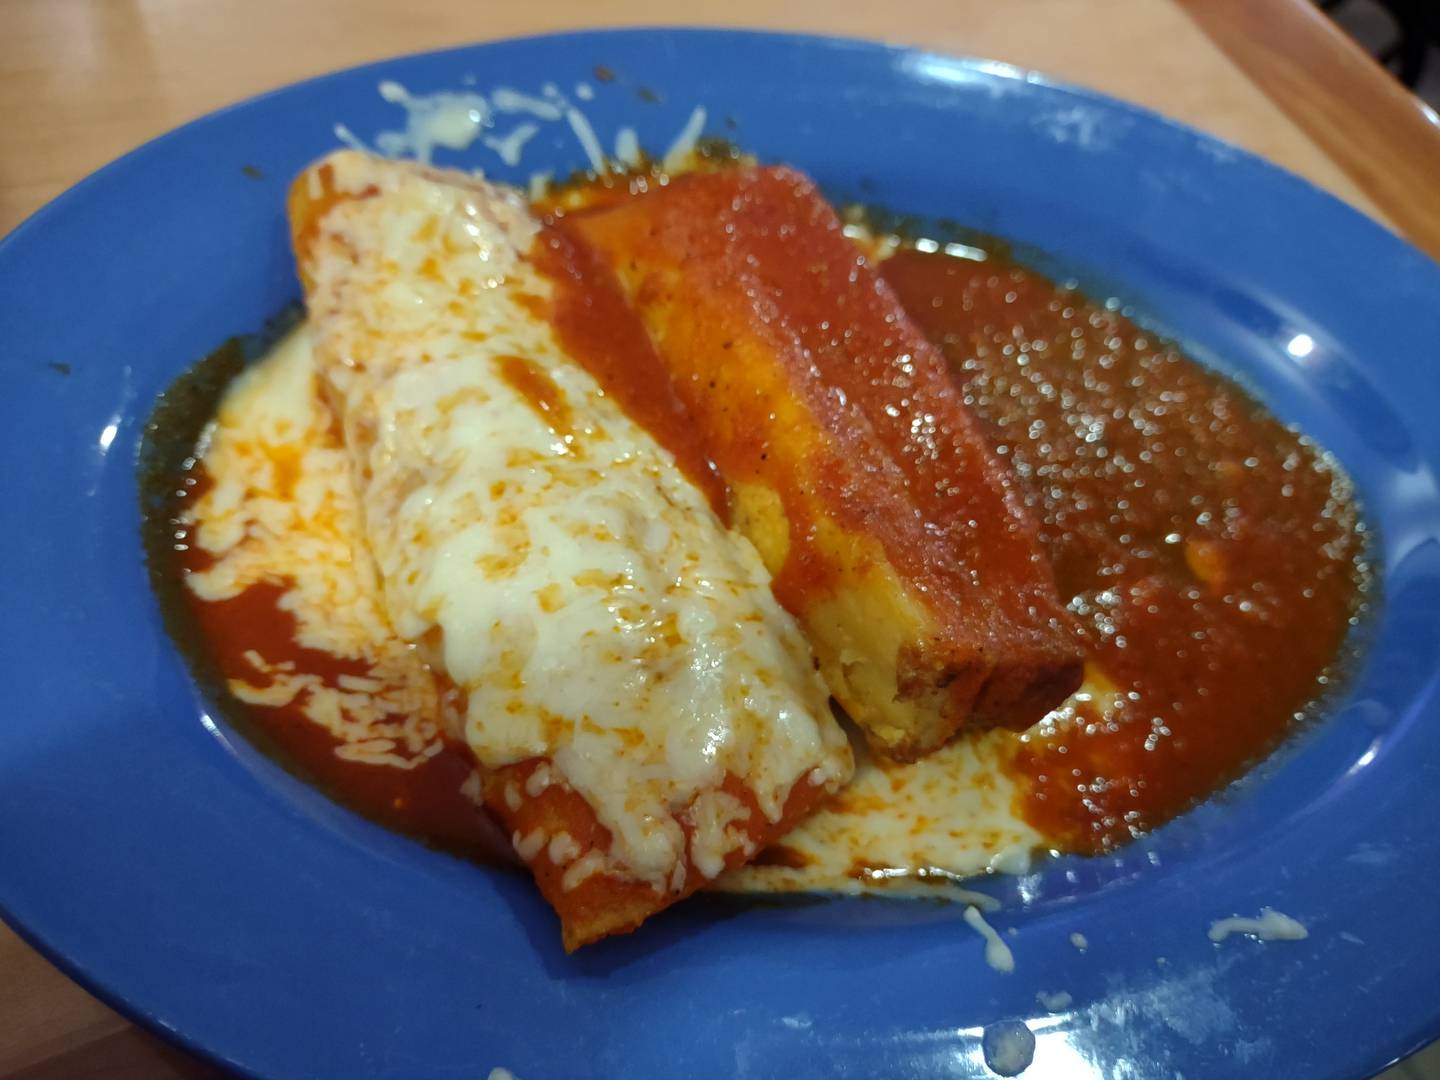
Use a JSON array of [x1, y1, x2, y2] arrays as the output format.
[[186, 330, 442, 769]]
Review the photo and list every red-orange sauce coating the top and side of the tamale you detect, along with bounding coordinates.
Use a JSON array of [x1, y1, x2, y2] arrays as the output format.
[[559, 168, 1067, 651]]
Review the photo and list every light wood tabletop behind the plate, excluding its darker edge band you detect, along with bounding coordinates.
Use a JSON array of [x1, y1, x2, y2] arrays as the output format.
[[0, 0, 1393, 230]]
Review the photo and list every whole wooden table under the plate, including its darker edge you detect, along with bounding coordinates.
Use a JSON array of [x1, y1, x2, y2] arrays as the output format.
[[0, 0, 1440, 1080]]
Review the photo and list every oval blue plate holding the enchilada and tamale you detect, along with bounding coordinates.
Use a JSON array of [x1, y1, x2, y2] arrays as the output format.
[[0, 30, 1440, 1080]]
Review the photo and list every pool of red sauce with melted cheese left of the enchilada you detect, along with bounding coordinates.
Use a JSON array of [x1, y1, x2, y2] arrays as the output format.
[[141, 330, 514, 863]]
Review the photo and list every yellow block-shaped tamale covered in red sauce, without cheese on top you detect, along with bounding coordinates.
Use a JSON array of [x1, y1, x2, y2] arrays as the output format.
[[560, 168, 1083, 760]]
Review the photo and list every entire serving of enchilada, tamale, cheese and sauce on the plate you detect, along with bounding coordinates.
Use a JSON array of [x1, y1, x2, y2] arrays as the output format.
[[140, 139, 1368, 948]]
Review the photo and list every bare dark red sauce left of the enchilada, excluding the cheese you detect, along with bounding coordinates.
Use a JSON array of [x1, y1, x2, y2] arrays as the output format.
[[174, 495, 514, 863]]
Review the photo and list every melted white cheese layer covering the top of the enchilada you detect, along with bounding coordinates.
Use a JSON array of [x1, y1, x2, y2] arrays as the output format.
[[304, 153, 850, 888]]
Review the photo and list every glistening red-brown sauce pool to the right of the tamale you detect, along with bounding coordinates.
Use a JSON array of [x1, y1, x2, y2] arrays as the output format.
[[883, 251, 1364, 851]]
